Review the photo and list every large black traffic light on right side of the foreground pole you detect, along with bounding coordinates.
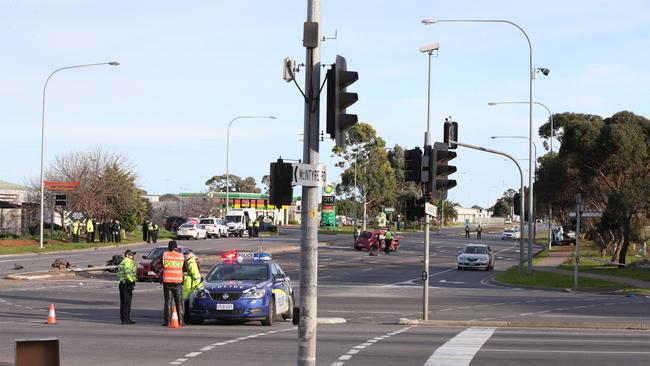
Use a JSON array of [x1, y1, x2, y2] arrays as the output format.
[[327, 55, 359, 147]]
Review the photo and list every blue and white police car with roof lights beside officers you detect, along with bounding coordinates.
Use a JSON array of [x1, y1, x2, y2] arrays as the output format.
[[188, 252, 295, 326]]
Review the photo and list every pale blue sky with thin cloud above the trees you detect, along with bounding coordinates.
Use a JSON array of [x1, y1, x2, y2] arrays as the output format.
[[0, 0, 650, 207]]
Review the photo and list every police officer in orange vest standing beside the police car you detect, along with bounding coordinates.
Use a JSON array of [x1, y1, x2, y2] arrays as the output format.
[[151, 240, 185, 326]]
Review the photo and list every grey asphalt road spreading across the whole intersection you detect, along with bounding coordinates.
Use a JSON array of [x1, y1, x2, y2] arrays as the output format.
[[0, 229, 650, 366]]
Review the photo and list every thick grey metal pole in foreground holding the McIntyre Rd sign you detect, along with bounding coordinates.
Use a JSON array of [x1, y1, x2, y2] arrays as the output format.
[[297, 0, 321, 366]]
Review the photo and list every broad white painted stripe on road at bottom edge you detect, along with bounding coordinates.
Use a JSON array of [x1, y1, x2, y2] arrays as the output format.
[[424, 328, 495, 366]]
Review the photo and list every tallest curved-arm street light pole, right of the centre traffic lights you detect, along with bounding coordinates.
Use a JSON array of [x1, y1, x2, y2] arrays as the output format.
[[422, 19, 535, 274]]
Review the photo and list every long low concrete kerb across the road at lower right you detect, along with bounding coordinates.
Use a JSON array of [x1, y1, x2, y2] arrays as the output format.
[[394, 318, 650, 331]]
